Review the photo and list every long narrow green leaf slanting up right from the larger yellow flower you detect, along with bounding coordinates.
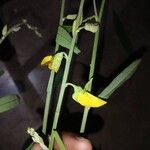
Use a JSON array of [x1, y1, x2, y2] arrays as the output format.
[[98, 59, 141, 99]]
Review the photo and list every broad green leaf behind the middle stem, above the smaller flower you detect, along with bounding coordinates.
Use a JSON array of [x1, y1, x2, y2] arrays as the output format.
[[56, 26, 80, 54]]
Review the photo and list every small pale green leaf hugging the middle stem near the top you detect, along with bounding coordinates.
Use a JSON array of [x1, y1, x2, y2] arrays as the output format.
[[72, 13, 83, 36]]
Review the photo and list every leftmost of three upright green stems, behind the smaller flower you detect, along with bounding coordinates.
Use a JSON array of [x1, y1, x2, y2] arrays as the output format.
[[42, 0, 65, 134]]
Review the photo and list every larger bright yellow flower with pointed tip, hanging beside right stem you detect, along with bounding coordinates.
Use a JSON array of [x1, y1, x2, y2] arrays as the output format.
[[72, 86, 107, 108]]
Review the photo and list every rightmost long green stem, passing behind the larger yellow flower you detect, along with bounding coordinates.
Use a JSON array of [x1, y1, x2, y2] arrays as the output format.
[[80, 0, 105, 133]]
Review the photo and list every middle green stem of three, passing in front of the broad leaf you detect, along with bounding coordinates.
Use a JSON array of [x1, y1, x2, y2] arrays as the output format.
[[52, 0, 84, 130]]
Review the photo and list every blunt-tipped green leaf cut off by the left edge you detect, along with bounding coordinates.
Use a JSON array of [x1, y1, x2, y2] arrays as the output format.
[[0, 94, 20, 113]]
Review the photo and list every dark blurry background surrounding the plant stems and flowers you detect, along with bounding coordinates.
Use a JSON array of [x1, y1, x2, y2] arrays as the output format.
[[0, 0, 150, 150]]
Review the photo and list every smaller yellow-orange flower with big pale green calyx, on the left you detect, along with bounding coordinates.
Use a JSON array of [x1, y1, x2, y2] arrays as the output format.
[[41, 52, 63, 72]]
